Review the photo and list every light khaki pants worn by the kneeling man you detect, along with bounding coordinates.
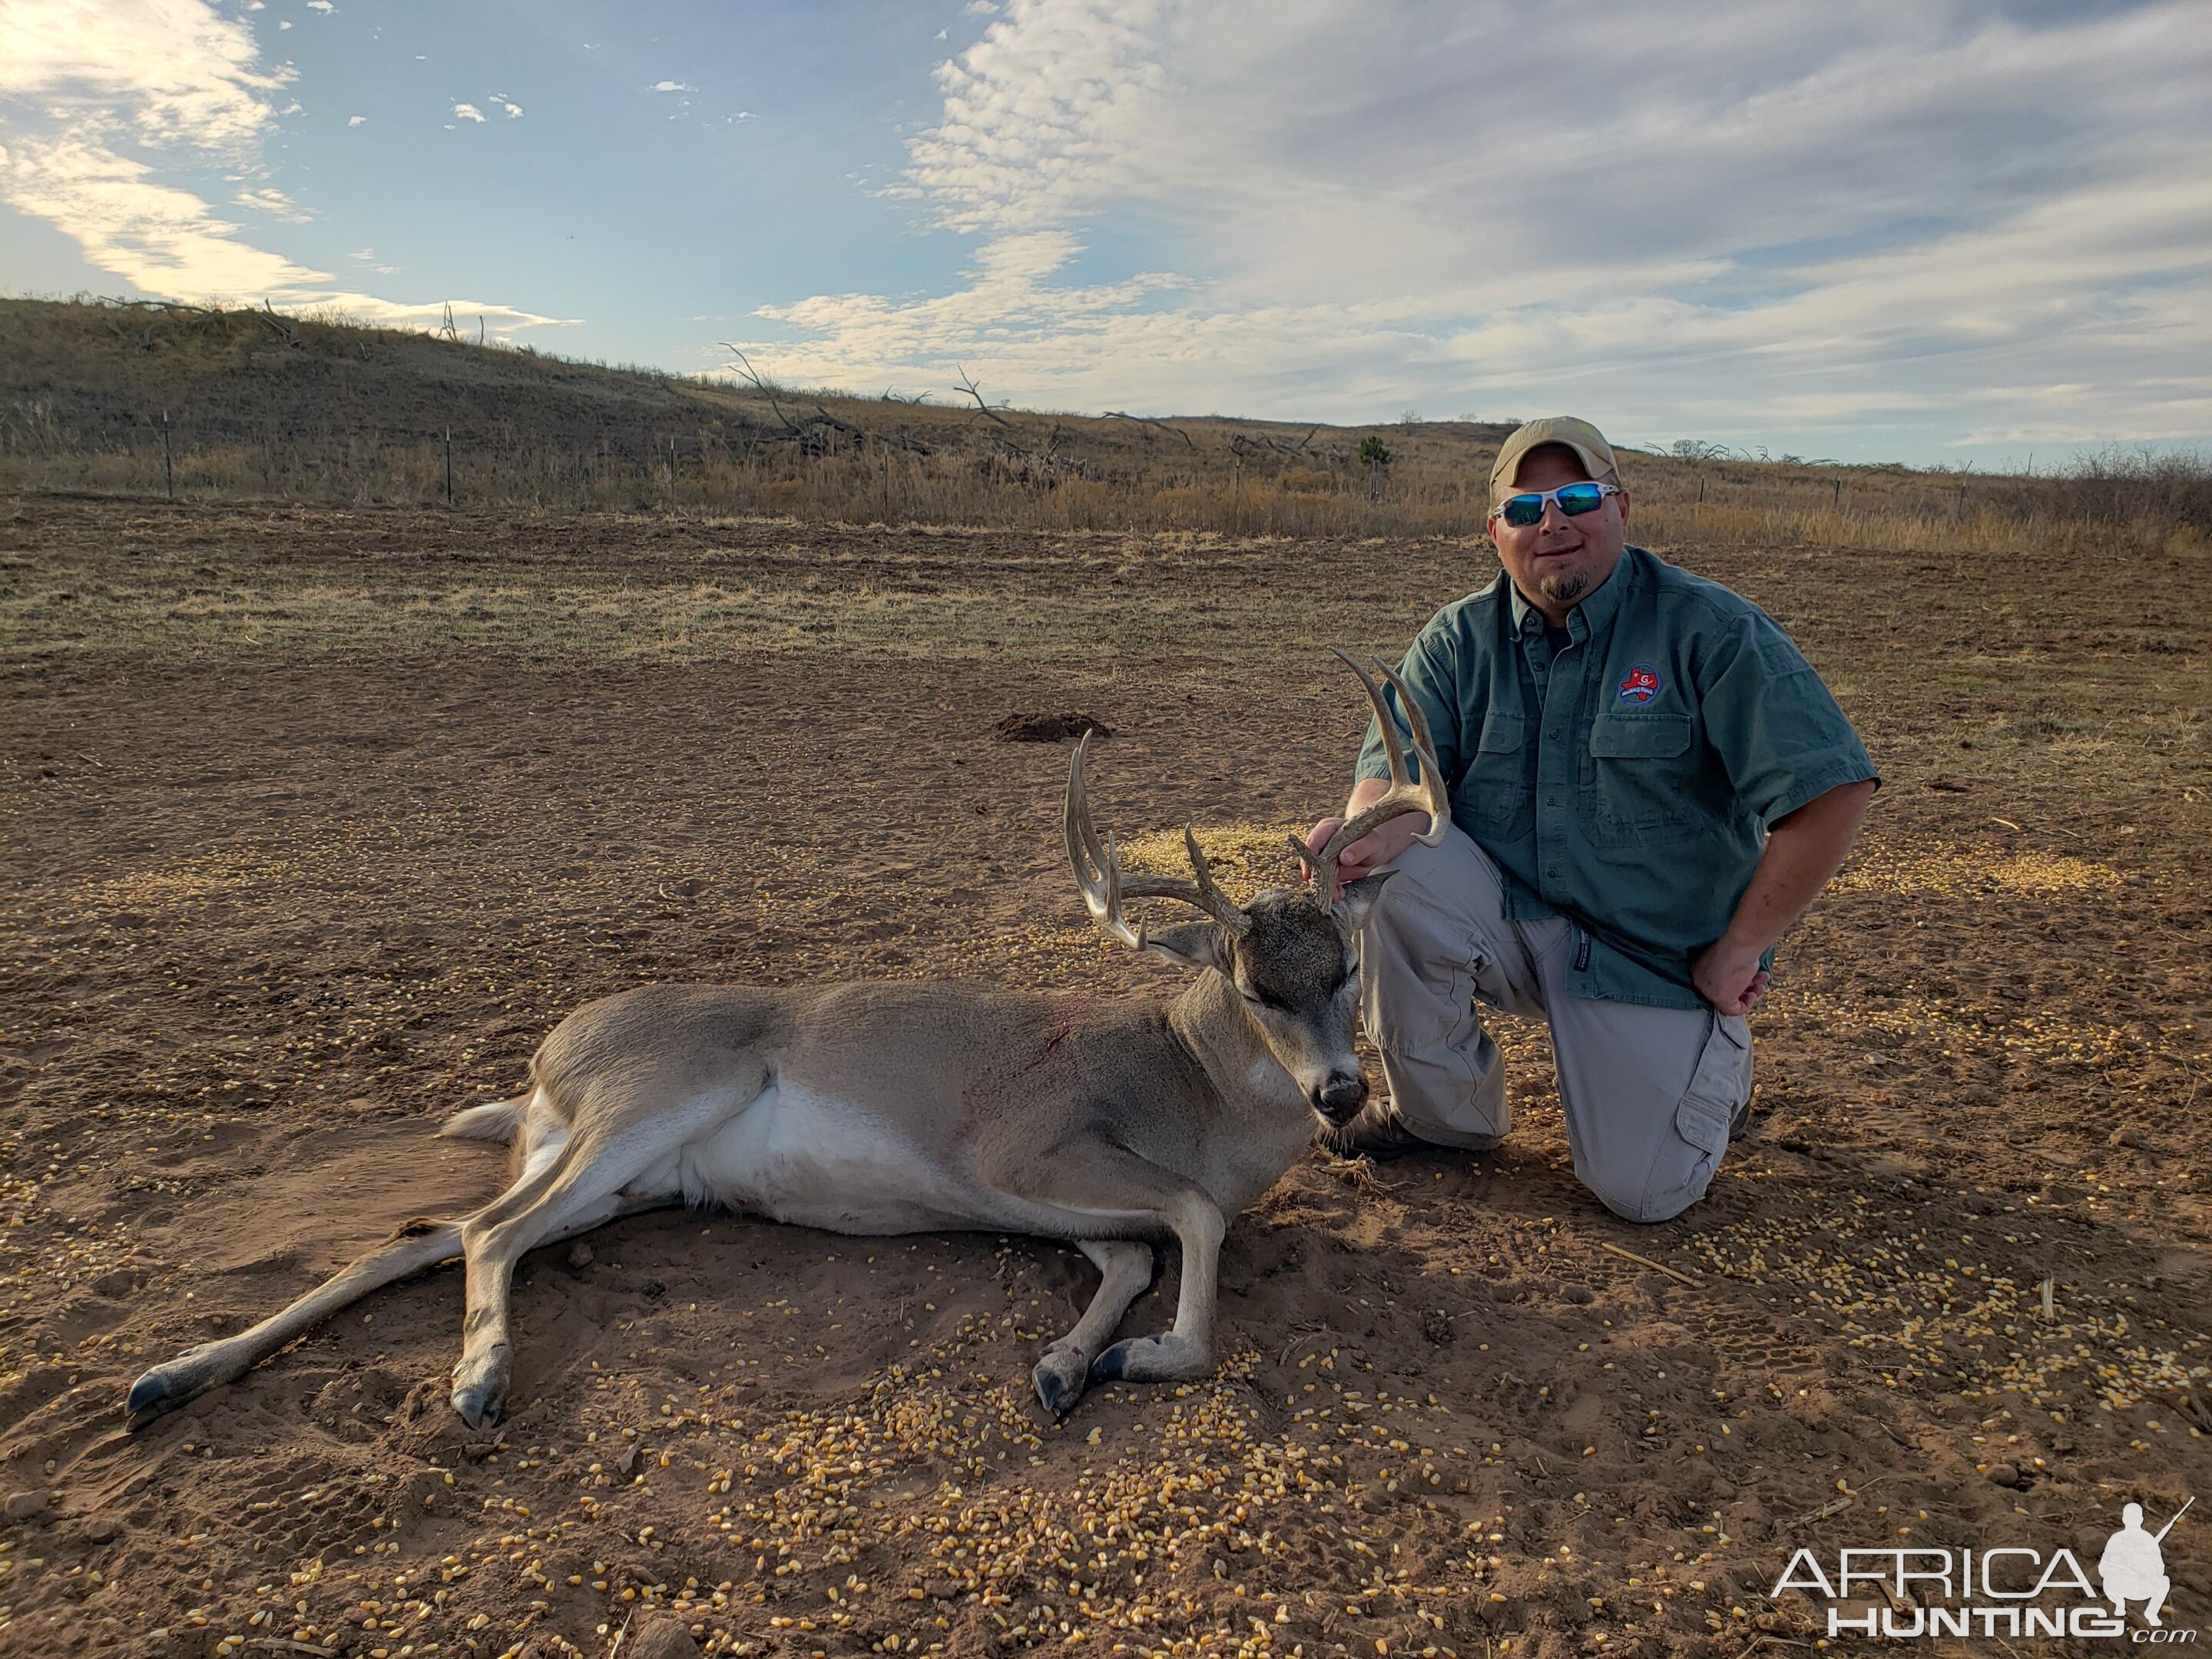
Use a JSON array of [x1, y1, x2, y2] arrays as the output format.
[[1360, 830, 1752, 1221]]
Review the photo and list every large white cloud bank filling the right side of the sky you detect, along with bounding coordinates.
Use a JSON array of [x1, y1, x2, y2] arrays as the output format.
[[757, 0, 2212, 455]]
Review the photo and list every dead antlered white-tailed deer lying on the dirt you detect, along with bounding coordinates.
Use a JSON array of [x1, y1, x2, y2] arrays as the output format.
[[138, 653, 1449, 1427]]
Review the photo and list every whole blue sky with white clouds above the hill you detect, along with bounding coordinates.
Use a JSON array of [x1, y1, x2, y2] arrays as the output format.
[[0, 0, 2212, 465]]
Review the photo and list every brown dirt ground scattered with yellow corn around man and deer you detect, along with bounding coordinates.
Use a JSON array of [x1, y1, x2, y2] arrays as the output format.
[[0, 500, 2212, 1659]]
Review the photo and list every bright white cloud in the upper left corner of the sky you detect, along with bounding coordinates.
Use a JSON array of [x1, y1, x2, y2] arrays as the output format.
[[0, 0, 579, 334]]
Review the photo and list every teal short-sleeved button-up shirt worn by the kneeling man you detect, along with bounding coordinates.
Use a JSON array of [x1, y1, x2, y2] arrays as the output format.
[[1358, 546, 1876, 1008]]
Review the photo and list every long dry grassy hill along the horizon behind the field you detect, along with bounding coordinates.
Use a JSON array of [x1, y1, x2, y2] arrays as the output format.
[[0, 299, 2212, 548]]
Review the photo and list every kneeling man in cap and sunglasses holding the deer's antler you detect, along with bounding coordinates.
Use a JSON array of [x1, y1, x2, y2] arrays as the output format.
[[1307, 416, 1878, 1221]]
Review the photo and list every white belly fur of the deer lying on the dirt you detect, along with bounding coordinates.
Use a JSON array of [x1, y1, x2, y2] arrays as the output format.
[[631, 1084, 1011, 1234]]
